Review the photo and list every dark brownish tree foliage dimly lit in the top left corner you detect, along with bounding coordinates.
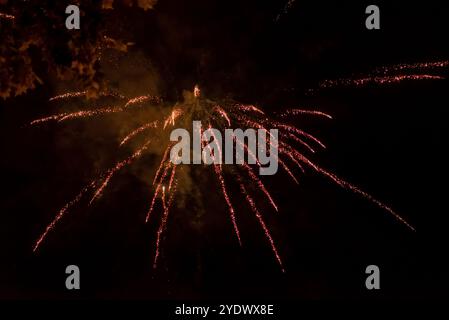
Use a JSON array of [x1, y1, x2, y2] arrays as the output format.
[[0, 0, 157, 99]]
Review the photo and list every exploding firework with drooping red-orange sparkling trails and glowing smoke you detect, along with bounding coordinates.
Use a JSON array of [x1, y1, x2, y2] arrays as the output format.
[[30, 62, 438, 271]]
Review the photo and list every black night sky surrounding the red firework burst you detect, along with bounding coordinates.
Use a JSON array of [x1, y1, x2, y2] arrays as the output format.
[[0, 0, 449, 300]]
